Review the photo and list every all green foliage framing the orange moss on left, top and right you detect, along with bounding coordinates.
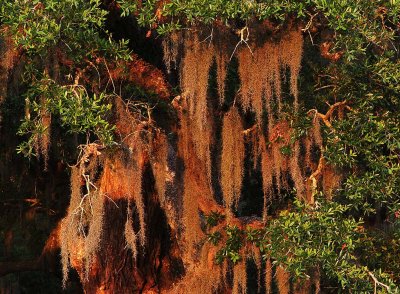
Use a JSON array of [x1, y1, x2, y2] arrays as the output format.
[[0, 0, 400, 291]]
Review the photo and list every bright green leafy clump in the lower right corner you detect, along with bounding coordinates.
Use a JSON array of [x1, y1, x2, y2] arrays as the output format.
[[208, 198, 399, 292]]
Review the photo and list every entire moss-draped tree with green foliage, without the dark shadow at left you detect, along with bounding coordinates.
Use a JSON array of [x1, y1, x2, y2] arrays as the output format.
[[0, 0, 400, 293]]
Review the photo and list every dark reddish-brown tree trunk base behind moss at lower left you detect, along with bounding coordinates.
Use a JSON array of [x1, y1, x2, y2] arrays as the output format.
[[77, 168, 183, 293]]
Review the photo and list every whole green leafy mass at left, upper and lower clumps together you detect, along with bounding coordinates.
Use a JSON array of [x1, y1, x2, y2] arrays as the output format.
[[0, 0, 130, 156]]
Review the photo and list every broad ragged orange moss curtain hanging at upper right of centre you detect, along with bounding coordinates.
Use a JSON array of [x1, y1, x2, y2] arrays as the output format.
[[238, 29, 303, 117]]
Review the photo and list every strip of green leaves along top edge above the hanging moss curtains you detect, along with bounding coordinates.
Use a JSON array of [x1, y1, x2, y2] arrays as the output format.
[[117, 0, 400, 37]]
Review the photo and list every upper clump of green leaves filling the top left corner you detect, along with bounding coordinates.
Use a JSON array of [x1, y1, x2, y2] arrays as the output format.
[[0, 0, 129, 60]]
